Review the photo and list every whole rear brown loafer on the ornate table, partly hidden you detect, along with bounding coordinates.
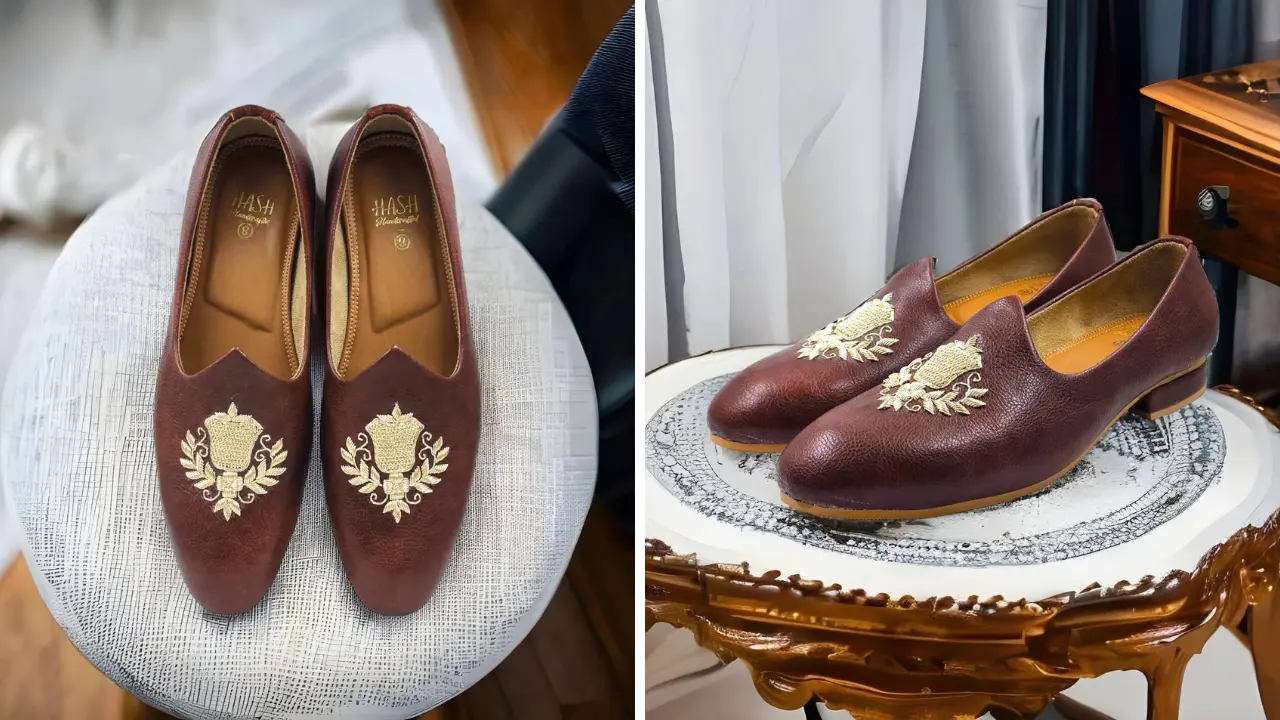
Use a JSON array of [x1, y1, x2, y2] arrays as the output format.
[[707, 200, 1115, 452]]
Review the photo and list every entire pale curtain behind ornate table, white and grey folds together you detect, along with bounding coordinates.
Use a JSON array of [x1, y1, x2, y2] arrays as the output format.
[[645, 0, 1046, 368]]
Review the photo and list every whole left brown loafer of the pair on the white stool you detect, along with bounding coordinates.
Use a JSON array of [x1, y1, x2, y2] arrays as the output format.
[[155, 105, 315, 614]]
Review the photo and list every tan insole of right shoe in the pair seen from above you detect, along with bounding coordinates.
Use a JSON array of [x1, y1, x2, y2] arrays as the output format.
[[342, 132, 458, 377]]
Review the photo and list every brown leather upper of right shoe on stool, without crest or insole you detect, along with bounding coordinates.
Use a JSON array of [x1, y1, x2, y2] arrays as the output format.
[[320, 105, 481, 615]]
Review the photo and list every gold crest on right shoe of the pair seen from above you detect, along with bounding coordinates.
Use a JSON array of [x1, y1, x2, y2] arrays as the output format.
[[340, 402, 449, 523]]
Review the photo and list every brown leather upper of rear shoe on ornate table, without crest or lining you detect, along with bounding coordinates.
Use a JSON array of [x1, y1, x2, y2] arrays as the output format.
[[707, 200, 1115, 445]]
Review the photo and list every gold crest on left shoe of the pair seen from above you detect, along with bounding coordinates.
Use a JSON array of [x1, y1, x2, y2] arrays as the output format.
[[178, 402, 289, 521]]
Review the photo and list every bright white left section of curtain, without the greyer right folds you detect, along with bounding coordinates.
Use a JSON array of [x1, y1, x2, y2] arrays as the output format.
[[646, 0, 924, 364]]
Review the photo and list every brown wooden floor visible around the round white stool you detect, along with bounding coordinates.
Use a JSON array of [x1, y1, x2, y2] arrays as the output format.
[[0, 0, 635, 720]]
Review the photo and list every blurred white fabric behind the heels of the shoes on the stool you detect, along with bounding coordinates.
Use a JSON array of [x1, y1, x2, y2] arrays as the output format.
[[0, 0, 497, 220]]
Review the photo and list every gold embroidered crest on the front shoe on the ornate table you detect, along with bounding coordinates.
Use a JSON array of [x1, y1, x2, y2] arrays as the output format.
[[879, 336, 987, 416]]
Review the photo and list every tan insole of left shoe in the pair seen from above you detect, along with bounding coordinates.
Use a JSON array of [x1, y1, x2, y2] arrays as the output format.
[[180, 136, 298, 379]]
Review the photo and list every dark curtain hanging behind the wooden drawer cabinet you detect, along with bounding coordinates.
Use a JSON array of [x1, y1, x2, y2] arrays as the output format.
[[1043, 0, 1253, 250]]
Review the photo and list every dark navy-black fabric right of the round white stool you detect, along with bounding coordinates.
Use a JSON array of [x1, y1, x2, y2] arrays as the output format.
[[488, 8, 635, 527]]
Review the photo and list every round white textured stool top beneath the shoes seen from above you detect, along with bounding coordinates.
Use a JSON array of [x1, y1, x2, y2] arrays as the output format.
[[0, 139, 598, 719]]
